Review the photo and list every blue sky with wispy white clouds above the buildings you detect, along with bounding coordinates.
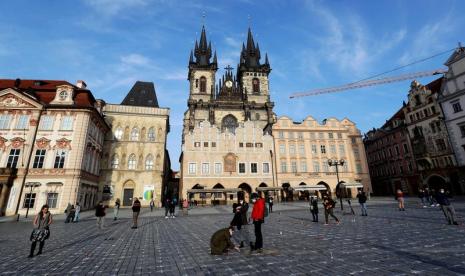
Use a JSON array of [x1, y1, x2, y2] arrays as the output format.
[[0, 0, 465, 169]]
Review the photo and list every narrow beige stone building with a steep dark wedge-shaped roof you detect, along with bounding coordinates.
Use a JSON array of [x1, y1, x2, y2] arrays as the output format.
[[100, 81, 169, 206]]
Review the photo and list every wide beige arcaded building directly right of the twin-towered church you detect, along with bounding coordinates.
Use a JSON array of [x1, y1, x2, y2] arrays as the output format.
[[273, 116, 372, 200]]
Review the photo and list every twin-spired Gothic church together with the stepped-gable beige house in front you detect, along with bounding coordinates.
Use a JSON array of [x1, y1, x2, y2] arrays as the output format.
[[180, 28, 275, 203]]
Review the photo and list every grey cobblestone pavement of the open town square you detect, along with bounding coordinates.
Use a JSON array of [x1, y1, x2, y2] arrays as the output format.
[[0, 199, 465, 275]]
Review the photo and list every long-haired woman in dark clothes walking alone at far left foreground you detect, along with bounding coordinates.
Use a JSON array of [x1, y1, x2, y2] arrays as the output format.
[[28, 204, 53, 258]]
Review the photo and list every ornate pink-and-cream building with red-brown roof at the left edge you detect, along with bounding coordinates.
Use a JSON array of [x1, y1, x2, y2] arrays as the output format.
[[0, 79, 109, 215]]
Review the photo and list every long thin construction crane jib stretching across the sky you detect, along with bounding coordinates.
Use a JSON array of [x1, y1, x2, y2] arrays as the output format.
[[289, 68, 447, 99]]
